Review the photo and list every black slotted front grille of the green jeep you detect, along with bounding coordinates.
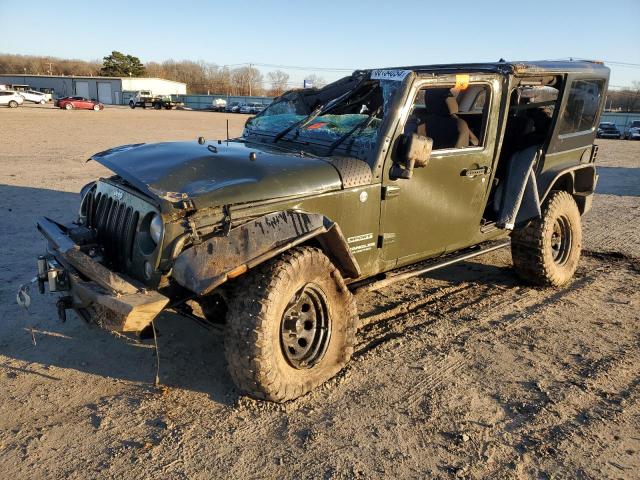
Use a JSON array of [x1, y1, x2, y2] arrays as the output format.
[[84, 189, 140, 272]]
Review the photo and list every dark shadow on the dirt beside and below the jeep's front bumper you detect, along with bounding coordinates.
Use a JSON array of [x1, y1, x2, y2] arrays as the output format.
[[0, 185, 238, 405]]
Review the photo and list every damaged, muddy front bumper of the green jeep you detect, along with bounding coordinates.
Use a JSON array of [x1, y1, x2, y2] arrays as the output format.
[[37, 217, 169, 332]]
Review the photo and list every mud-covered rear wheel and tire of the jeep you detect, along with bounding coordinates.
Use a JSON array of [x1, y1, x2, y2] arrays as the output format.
[[511, 191, 582, 287]]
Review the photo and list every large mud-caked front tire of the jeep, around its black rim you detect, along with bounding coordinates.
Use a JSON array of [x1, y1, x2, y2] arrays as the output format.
[[225, 247, 358, 402]]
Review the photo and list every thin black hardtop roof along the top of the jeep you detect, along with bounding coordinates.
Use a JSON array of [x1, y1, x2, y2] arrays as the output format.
[[384, 60, 609, 75]]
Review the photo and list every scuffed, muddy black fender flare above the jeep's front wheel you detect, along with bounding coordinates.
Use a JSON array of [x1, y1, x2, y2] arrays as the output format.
[[171, 210, 360, 295]]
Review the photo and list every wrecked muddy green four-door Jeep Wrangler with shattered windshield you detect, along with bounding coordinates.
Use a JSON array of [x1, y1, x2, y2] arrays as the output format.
[[33, 61, 609, 402]]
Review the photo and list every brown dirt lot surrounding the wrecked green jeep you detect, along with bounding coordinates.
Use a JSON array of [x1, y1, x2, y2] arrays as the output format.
[[0, 107, 640, 480]]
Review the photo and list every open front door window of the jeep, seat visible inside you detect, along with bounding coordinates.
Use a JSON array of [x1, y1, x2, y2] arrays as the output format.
[[404, 84, 490, 150]]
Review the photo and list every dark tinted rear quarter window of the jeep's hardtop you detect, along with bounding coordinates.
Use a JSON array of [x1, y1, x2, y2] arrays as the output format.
[[559, 80, 604, 135]]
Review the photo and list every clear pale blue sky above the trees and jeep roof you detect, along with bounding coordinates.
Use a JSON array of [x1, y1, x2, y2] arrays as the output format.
[[0, 0, 640, 85]]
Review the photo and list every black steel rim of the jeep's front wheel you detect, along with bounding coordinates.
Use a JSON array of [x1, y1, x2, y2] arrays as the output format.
[[280, 283, 331, 369]]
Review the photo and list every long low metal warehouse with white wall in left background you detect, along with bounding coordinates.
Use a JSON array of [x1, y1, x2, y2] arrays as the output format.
[[0, 75, 187, 104]]
